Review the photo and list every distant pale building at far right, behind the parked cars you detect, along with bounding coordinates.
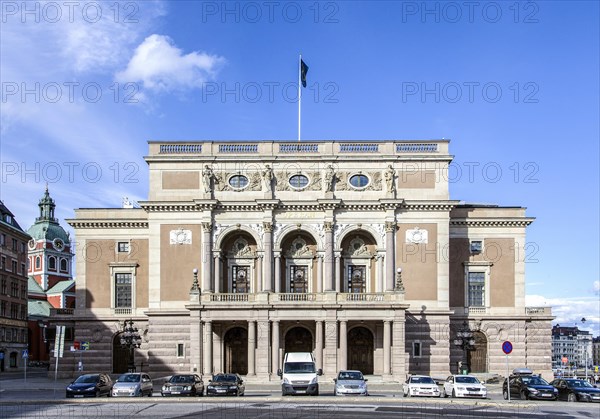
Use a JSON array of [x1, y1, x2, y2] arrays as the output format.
[[552, 325, 593, 368]]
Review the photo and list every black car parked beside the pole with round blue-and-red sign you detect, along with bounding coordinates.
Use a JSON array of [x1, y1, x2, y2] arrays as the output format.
[[502, 368, 558, 400]]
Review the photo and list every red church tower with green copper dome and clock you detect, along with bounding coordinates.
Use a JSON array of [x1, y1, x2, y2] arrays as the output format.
[[27, 188, 75, 361]]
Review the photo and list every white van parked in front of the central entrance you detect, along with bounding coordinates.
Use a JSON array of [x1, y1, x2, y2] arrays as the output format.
[[277, 352, 323, 396]]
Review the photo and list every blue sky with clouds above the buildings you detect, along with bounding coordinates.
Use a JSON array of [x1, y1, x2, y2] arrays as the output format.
[[0, 1, 600, 334]]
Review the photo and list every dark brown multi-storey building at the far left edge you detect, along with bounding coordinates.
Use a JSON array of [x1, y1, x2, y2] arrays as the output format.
[[0, 201, 29, 372]]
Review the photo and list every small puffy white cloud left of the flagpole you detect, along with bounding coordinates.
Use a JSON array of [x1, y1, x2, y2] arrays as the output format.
[[116, 34, 225, 92]]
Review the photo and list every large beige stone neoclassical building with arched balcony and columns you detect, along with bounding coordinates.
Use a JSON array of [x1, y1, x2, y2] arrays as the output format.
[[59, 140, 552, 381]]
